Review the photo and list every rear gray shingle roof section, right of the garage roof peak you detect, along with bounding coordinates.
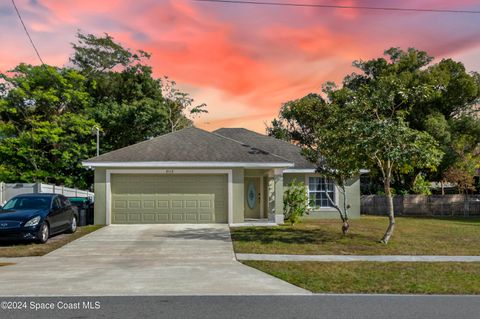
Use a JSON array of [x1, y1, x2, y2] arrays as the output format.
[[213, 128, 316, 169]]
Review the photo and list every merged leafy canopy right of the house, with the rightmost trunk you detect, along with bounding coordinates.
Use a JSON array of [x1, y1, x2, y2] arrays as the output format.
[[268, 48, 480, 243]]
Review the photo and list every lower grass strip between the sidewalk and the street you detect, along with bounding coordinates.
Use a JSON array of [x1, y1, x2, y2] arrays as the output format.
[[244, 261, 480, 294]]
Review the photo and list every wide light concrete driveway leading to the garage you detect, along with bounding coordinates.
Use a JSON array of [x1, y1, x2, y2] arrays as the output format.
[[0, 225, 308, 296]]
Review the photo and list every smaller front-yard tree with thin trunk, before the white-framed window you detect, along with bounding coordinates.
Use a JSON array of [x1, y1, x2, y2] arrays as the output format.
[[268, 90, 362, 234]]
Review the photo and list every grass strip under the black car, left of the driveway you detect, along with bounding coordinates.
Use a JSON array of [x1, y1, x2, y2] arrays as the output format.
[[0, 225, 103, 257]]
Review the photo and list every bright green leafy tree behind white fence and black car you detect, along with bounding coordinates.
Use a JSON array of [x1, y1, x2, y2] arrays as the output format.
[[0, 64, 98, 187]]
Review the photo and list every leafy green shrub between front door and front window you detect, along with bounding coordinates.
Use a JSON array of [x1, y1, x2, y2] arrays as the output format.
[[283, 180, 310, 224]]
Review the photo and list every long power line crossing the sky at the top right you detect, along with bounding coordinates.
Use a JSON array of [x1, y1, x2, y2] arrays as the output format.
[[194, 0, 480, 14]]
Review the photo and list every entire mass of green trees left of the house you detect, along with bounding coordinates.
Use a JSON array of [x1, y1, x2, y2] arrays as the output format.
[[0, 33, 206, 188]]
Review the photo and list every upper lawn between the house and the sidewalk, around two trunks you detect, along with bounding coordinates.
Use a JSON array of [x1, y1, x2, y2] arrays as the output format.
[[231, 216, 480, 255]]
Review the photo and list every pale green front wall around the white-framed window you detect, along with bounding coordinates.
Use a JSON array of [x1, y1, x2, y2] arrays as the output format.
[[283, 173, 360, 219]]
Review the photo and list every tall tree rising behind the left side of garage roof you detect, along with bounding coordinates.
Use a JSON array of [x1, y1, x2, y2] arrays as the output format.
[[70, 32, 207, 151]]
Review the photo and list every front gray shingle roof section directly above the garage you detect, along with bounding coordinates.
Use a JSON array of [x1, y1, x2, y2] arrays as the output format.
[[84, 127, 292, 165]]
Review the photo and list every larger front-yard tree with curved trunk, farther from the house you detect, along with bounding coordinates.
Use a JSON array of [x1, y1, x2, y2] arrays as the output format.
[[268, 48, 443, 244]]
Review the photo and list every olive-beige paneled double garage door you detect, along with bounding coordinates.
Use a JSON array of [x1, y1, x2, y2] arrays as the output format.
[[111, 174, 228, 224]]
